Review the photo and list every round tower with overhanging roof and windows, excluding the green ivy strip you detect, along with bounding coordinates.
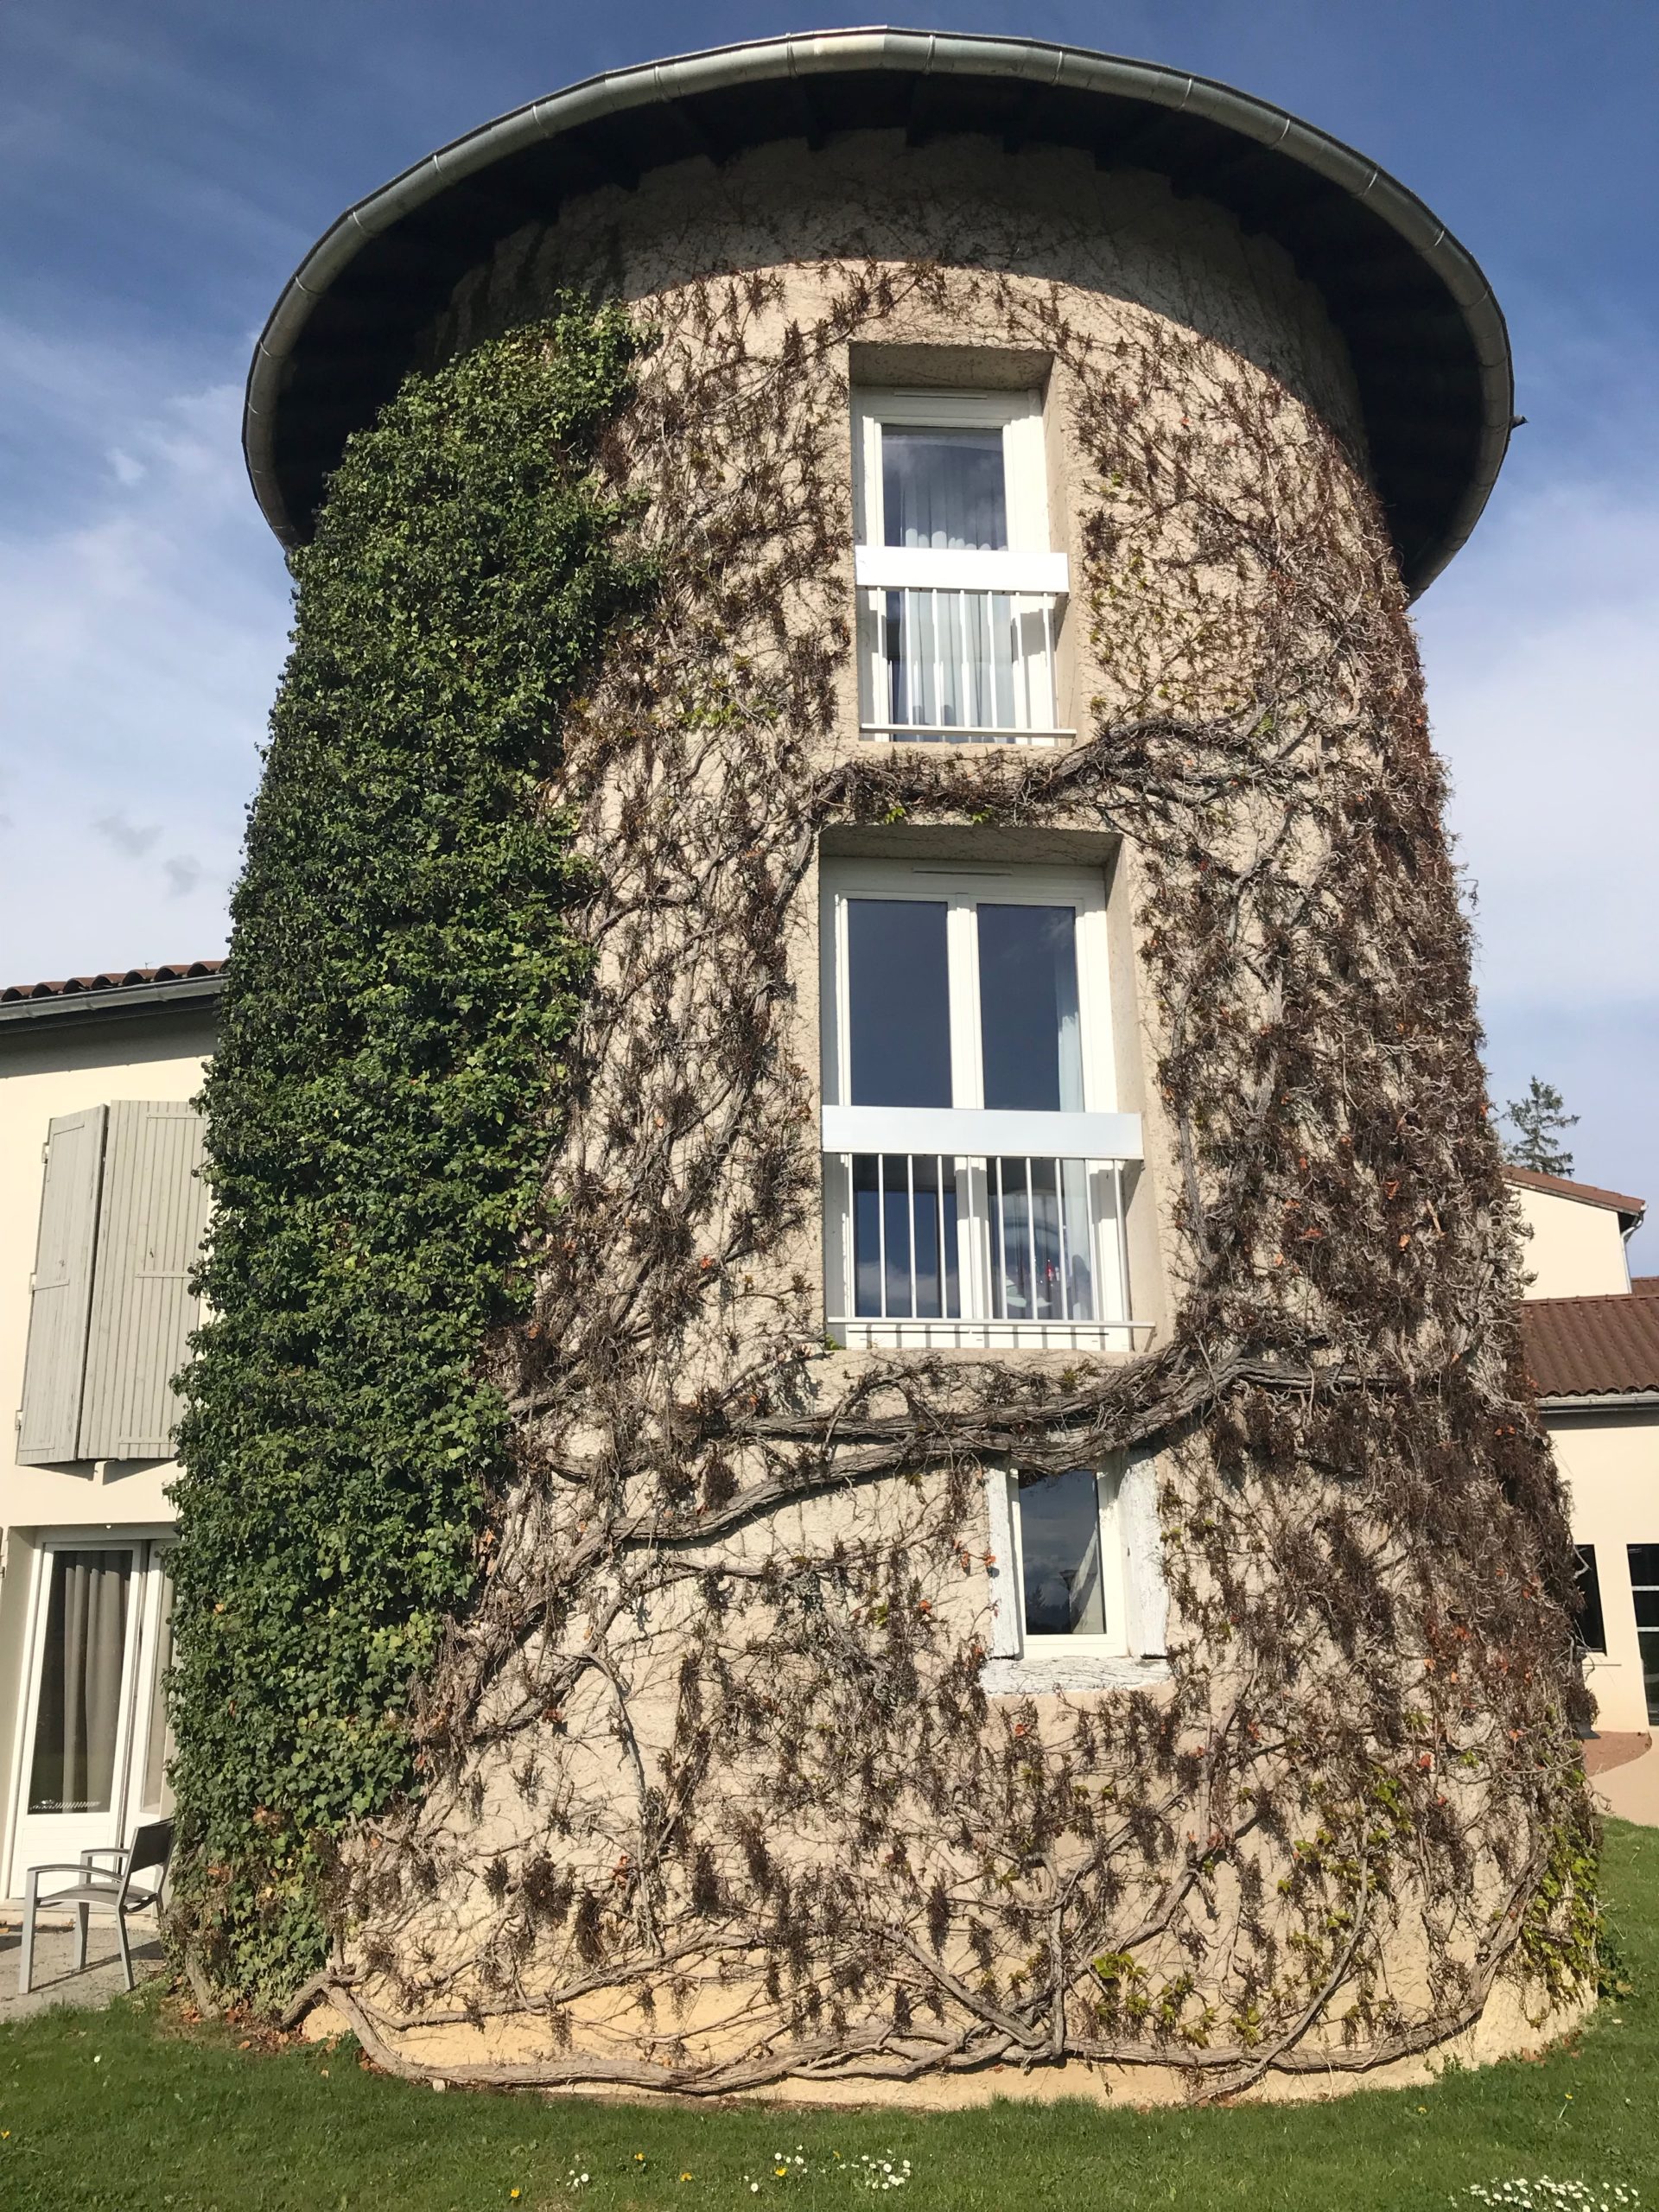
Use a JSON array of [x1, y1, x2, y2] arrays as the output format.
[[181, 31, 1592, 2097]]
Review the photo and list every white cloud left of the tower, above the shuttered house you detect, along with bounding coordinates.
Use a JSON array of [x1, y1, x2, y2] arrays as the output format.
[[0, 323, 288, 982]]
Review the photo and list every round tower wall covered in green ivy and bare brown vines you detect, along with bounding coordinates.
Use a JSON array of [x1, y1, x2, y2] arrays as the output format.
[[179, 143, 1592, 2094]]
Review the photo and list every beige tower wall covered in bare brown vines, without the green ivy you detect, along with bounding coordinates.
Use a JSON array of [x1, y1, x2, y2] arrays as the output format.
[[298, 246, 1591, 2094]]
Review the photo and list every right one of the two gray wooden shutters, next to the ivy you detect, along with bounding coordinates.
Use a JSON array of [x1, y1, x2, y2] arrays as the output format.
[[79, 1099, 208, 1460]]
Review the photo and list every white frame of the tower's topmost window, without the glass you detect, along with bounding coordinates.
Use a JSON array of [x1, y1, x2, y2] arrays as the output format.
[[852, 387, 1073, 746]]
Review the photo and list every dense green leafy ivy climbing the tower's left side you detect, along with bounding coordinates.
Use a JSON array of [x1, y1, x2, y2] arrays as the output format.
[[173, 301, 651, 2002]]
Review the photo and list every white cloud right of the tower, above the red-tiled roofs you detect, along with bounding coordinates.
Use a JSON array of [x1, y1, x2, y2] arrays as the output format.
[[1421, 414, 1659, 1269]]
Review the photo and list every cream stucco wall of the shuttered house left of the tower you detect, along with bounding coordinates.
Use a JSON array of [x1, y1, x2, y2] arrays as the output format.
[[0, 1007, 214, 1865]]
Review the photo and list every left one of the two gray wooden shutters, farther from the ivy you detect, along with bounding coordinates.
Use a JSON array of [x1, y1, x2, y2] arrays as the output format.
[[17, 1106, 108, 1466]]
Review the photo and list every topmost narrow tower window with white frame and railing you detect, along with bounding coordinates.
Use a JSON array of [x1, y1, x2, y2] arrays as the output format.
[[854, 391, 1066, 743]]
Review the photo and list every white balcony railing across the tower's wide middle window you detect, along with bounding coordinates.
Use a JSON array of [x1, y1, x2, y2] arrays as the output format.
[[823, 1106, 1144, 1351]]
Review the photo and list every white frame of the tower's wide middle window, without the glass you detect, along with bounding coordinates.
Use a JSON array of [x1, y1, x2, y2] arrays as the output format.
[[821, 858, 1146, 1351]]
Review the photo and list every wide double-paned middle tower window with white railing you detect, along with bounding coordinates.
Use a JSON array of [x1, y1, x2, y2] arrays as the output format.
[[823, 861, 1139, 1350]]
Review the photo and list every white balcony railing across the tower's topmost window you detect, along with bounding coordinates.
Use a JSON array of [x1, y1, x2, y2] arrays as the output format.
[[856, 546, 1068, 746]]
